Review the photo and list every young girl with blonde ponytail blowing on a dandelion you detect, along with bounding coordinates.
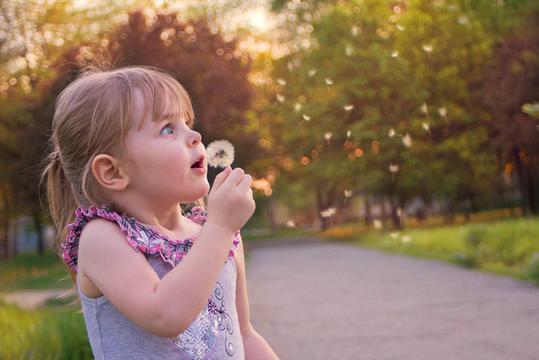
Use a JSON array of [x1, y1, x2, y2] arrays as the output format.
[[43, 66, 277, 359]]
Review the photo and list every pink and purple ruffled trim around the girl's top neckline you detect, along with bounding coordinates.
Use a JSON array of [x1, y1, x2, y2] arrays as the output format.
[[60, 205, 241, 273]]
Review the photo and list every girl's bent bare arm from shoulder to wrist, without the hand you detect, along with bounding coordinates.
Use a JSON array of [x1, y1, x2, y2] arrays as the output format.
[[79, 219, 234, 337]]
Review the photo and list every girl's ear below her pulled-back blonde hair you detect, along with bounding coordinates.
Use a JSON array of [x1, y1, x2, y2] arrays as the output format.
[[92, 154, 130, 191]]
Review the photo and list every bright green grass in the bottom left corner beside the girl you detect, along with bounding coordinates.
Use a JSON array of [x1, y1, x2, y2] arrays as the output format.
[[0, 302, 93, 360]]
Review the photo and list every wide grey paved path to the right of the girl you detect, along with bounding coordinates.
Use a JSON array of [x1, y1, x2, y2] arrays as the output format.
[[247, 241, 539, 360]]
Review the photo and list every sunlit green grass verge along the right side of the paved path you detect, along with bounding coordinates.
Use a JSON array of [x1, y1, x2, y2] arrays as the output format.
[[321, 218, 539, 284]]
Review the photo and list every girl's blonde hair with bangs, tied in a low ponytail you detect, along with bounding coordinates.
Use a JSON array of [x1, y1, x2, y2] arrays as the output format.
[[41, 66, 204, 279]]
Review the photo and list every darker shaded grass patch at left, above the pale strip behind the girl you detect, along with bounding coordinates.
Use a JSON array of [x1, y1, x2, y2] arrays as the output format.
[[0, 251, 72, 292]]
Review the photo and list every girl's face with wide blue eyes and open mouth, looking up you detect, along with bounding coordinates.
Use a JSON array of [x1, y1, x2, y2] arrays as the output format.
[[126, 90, 210, 205]]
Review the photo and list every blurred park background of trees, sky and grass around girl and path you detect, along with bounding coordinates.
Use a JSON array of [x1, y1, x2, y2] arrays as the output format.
[[0, 0, 539, 358]]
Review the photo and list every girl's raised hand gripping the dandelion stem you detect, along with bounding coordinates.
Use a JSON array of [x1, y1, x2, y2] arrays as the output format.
[[206, 166, 256, 231]]
